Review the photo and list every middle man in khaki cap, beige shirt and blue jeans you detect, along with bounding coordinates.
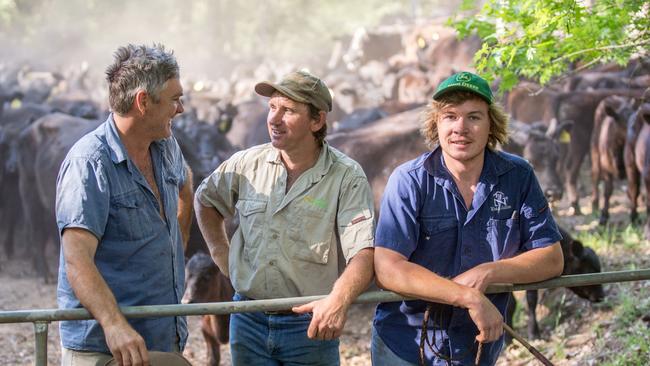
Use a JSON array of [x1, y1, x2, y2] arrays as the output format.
[[195, 71, 374, 365]]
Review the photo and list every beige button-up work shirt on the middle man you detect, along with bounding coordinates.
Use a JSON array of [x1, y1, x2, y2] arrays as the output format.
[[196, 143, 375, 299]]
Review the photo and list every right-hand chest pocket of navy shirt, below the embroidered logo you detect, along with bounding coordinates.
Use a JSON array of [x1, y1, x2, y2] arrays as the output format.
[[487, 218, 521, 261]]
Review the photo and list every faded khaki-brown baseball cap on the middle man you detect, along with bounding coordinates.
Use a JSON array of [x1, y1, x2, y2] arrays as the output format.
[[255, 71, 332, 112]]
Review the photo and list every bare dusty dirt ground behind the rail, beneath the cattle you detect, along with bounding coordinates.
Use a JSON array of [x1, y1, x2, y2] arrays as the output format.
[[0, 183, 650, 366]]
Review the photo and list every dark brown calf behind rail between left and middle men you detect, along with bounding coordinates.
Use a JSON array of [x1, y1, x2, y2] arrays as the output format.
[[182, 252, 234, 366]]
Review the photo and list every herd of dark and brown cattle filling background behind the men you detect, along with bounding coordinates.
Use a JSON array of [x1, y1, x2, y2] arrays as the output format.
[[0, 21, 650, 362]]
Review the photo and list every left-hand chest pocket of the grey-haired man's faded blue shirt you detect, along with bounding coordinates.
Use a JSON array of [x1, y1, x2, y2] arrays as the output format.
[[105, 190, 154, 241]]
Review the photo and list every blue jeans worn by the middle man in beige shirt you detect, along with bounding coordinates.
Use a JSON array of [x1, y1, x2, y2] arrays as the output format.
[[230, 294, 340, 366]]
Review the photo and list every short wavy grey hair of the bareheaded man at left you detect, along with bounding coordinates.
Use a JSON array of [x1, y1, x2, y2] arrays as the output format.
[[106, 44, 179, 114]]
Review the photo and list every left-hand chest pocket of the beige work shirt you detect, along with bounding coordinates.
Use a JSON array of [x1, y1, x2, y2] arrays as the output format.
[[236, 200, 266, 259]]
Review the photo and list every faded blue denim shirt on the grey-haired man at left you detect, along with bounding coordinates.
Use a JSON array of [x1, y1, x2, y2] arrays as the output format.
[[56, 115, 187, 353]]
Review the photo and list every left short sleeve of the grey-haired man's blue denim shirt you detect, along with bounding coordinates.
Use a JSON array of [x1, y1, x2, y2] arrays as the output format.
[[56, 157, 110, 240]]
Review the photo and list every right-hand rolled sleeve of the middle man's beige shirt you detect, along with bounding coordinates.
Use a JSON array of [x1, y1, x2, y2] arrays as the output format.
[[336, 175, 375, 263]]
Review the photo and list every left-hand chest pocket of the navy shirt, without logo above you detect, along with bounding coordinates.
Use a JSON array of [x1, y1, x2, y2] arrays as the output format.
[[412, 217, 458, 276]]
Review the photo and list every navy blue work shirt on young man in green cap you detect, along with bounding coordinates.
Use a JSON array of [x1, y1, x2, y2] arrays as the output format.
[[374, 147, 561, 365]]
